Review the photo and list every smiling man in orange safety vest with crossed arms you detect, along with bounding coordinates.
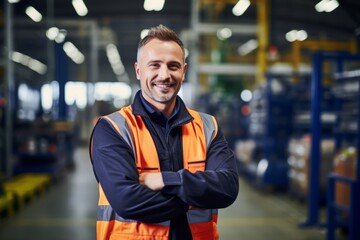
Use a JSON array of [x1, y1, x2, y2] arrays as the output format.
[[90, 25, 239, 240]]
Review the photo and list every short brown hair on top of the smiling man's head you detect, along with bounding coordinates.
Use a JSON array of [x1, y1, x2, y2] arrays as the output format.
[[138, 24, 185, 59]]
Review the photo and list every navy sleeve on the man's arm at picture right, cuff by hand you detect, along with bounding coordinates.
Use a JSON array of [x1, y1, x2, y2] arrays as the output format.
[[162, 128, 239, 209]]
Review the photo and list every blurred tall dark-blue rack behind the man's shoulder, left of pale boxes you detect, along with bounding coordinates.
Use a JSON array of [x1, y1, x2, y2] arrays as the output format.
[[246, 73, 293, 190]]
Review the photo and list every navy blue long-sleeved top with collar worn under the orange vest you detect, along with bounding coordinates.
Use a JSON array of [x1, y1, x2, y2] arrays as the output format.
[[92, 91, 239, 239]]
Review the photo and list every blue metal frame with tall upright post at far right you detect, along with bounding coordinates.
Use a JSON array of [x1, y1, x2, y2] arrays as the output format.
[[303, 52, 360, 240]]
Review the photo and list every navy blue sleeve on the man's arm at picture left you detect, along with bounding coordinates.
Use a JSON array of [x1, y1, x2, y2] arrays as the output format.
[[91, 119, 189, 223]]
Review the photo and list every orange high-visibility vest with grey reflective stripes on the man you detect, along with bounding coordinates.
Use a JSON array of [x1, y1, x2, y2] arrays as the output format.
[[96, 106, 218, 240]]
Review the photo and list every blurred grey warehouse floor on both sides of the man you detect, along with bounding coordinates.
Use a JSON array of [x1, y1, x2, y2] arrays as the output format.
[[0, 148, 348, 240]]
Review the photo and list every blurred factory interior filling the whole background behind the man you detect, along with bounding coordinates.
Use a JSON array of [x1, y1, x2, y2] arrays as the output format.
[[0, 0, 360, 240]]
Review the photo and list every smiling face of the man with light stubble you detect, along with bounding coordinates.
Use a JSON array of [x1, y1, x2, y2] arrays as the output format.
[[135, 39, 187, 108]]
